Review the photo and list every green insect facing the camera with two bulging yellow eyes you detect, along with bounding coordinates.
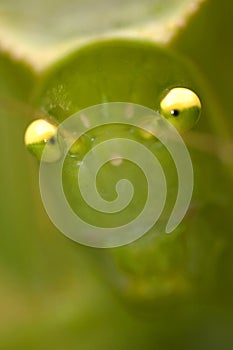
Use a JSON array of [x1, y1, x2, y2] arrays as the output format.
[[25, 40, 207, 299]]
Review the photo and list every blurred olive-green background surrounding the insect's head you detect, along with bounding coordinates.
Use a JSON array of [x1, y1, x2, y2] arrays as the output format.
[[0, 0, 233, 350]]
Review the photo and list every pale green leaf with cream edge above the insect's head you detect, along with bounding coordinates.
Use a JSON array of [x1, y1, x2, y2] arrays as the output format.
[[0, 0, 204, 70]]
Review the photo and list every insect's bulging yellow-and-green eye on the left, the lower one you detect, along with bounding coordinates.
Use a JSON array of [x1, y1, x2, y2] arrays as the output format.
[[24, 119, 61, 163]]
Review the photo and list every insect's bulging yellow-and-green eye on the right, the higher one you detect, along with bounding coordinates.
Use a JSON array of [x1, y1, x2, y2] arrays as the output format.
[[160, 87, 201, 132]]
